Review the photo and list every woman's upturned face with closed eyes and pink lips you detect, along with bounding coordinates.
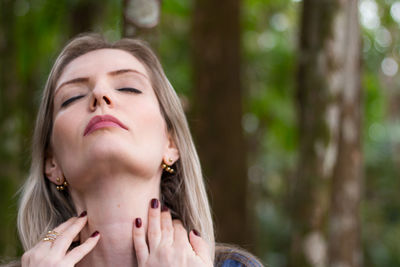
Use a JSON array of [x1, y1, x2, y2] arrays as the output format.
[[46, 49, 177, 189]]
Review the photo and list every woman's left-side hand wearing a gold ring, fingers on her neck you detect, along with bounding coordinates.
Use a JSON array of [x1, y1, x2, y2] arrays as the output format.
[[21, 212, 100, 267]]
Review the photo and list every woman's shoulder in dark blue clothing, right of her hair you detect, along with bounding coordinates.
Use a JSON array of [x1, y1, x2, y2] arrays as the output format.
[[214, 244, 263, 267]]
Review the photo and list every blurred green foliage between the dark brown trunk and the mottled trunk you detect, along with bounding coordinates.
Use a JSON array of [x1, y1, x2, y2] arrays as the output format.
[[242, 0, 299, 266]]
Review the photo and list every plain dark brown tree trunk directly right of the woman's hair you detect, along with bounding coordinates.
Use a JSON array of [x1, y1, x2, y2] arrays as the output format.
[[192, 0, 250, 249]]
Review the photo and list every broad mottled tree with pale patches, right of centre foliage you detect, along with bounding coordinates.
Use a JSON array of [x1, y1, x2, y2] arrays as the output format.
[[290, 0, 362, 266]]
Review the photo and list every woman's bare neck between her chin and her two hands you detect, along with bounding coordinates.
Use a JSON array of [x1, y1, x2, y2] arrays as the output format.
[[71, 174, 161, 267]]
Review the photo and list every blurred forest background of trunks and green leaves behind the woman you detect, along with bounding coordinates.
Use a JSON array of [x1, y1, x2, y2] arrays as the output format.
[[0, 0, 400, 267]]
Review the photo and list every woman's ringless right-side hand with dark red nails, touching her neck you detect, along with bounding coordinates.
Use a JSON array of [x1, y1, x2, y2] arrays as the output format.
[[133, 199, 213, 267]]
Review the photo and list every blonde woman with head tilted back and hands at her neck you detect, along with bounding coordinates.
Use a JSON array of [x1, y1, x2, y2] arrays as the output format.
[[5, 35, 261, 267]]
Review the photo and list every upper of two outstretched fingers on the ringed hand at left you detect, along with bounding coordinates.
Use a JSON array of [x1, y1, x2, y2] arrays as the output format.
[[53, 215, 87, 255]]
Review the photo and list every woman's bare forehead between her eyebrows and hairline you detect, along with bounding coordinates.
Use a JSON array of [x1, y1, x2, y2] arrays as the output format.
[[56, 48, 148, 88]]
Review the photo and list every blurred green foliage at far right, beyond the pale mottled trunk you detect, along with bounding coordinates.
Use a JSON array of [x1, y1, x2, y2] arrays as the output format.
[[360, 1, 400, 266]]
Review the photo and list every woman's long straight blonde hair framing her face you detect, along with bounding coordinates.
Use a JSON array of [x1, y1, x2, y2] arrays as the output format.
[[18, 34, 215, 257]]
